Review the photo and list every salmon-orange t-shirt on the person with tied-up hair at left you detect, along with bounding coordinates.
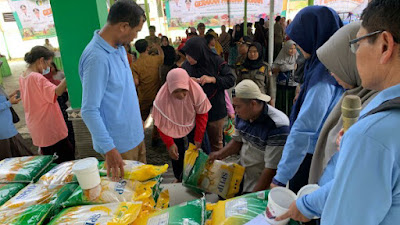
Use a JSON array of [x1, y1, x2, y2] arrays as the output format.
[[19, 72, 68, 147]]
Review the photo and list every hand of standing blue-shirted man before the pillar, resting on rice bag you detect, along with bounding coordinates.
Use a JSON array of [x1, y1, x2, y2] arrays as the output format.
[[106, 148, 125, 181]]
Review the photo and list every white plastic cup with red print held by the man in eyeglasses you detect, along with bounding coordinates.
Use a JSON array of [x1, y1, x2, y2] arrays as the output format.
[[266, 187, 297, 225]]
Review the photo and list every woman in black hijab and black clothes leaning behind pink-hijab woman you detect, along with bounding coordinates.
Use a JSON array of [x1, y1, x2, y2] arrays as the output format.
[[182, 37, 236, 151]]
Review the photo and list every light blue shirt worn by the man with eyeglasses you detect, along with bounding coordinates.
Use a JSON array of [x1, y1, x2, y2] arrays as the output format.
[[296, 85, 400, 225]]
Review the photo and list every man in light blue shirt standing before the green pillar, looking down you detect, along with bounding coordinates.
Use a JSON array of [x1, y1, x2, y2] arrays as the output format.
[[79, 0, 146, 180]]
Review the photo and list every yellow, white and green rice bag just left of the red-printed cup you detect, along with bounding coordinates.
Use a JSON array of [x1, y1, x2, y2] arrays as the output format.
[[207, 190, 298, 225]]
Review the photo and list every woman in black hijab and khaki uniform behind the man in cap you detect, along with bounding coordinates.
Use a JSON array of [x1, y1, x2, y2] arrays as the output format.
[[235, 42, 276, 106]]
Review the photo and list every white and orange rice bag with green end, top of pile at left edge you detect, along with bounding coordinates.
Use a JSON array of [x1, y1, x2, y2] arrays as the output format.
[[0, 155, 55, 183]]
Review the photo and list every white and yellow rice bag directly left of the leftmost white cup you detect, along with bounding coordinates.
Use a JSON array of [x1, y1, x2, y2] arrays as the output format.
[[37, 161, 78, 185]]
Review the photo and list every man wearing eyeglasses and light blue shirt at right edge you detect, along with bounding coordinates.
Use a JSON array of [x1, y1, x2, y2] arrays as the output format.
[[277, 0, 400, 225]]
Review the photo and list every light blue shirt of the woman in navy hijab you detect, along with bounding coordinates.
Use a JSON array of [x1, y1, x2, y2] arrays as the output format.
[[274, 82, 344, 184]]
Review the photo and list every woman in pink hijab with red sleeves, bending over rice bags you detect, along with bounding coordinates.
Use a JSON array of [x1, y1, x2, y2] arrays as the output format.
[[153, 68, 211, 180]]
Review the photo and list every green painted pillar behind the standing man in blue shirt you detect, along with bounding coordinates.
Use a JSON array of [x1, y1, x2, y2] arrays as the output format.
[[50, 0, 108, 109]]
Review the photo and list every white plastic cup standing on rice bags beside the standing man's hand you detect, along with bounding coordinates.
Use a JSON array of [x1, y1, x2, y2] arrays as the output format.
[[72, 157, 100, 190]]
